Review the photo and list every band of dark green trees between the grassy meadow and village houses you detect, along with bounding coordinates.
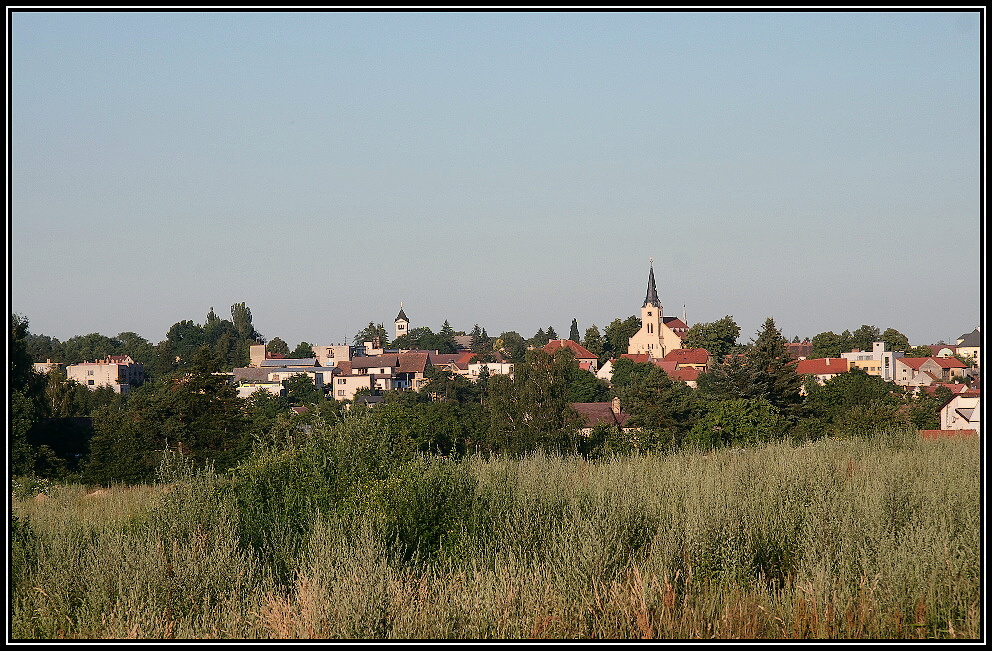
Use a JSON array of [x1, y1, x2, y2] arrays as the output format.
[[11, 313, 950, 485]]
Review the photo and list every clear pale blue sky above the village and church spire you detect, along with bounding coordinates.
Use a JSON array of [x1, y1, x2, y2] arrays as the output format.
[[8, 8, 984, 347]]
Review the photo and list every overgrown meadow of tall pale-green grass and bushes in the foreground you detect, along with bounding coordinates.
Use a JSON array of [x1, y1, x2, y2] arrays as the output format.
[[10, 415, 981, 640]]
